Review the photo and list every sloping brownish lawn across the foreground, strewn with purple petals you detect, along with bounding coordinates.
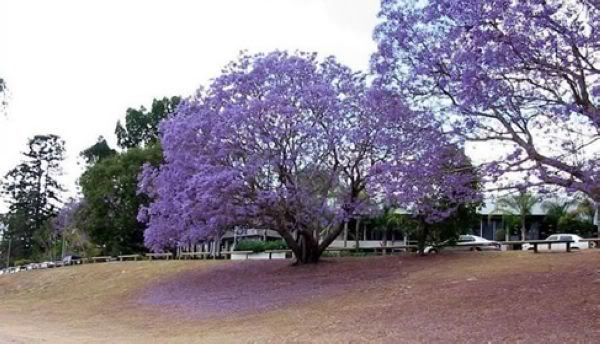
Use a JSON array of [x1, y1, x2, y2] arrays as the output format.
[[0, 250, 600, 343]]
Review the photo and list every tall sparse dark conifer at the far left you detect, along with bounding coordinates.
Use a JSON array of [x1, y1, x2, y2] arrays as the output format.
[[2, 135, 65, 258]]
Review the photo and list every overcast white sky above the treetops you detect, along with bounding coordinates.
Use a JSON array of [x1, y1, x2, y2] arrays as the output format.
[[0, 0, 379, 211]]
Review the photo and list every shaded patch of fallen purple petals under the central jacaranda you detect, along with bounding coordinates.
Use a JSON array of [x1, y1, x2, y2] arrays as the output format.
[[136, 257, 406, 318]]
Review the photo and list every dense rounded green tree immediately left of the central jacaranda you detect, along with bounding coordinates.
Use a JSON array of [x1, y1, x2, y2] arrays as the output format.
[[79, 145, 162, 254]]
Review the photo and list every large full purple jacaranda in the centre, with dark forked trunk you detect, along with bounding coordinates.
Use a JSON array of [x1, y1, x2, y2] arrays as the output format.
[[138, 52, 478, 263]]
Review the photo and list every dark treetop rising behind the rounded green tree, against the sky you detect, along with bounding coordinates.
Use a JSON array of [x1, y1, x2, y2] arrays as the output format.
[[115, 97, 181, 149]]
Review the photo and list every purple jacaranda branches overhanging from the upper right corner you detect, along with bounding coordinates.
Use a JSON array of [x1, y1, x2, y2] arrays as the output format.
[[372, 0, 600, 201]]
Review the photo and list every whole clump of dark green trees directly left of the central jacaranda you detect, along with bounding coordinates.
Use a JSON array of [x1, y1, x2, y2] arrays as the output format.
[[72, 97, 180, 256]]
